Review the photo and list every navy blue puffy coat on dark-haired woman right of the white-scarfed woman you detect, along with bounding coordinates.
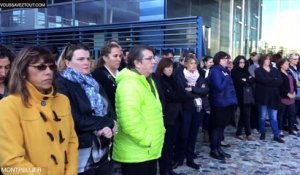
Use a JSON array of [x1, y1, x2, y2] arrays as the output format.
[[207, 65, 237, 107]]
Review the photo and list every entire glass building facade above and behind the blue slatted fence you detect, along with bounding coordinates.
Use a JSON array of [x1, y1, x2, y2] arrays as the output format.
[[0, 0, 262, 56]]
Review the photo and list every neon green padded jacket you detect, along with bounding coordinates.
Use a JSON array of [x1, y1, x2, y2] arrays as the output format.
[[112, 68, 165, 163]]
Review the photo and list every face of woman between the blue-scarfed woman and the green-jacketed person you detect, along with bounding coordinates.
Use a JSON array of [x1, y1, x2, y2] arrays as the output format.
[[103, 47, 122, 71]]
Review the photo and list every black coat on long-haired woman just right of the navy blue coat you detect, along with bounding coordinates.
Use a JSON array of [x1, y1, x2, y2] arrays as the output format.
[[231, 67, 255, 105]]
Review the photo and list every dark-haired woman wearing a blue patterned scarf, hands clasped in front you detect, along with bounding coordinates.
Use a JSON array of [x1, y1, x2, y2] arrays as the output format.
[[57, 44, 116, 175]]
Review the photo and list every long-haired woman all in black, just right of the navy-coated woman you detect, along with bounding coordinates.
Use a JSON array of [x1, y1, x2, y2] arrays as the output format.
[[231, 55, 254, 140]]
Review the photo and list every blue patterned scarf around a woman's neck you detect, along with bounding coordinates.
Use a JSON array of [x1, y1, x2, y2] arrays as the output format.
[[62, 67, 107, 116]]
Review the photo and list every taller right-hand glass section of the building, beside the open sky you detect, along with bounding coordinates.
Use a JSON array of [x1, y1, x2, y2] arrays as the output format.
[[166, 0, 261, 57]]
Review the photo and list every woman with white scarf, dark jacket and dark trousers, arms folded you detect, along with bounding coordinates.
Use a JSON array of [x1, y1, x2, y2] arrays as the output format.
[[175, 55, 208, 169]]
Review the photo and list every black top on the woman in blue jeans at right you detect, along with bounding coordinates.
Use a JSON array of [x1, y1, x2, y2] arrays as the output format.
[[255, 66, 282, 109]]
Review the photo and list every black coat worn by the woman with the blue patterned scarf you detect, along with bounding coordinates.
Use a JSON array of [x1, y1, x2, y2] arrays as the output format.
[[56, 76, 115, 148]]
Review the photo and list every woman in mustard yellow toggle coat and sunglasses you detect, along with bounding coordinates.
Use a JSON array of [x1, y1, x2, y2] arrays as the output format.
[[0, 47, 78, 175]]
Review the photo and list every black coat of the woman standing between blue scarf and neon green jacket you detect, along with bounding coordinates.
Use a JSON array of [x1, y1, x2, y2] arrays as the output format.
[[92, 66, 117, 111]]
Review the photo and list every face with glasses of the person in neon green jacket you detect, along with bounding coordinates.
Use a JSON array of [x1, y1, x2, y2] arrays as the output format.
[[135, 50, 157, 77]]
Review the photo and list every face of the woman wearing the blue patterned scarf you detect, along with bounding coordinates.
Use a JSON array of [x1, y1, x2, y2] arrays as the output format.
[[66, 49, 91, 75]]
